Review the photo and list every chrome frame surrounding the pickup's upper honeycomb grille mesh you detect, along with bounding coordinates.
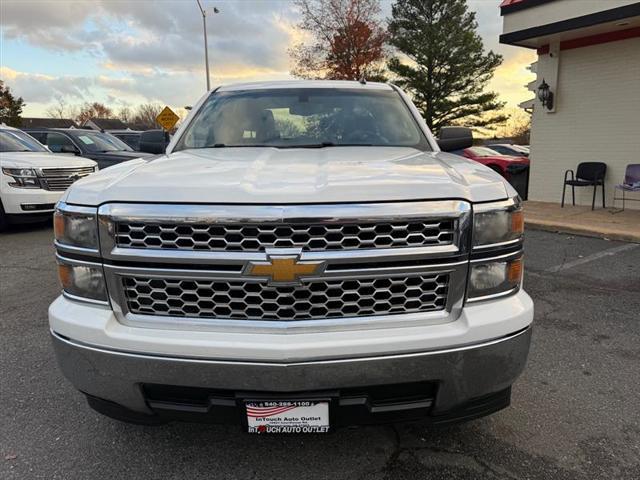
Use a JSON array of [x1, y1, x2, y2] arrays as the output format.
[[98, 200, 471, 263]]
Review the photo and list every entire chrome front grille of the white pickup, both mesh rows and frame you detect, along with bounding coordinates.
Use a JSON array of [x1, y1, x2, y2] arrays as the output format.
[[98, 200, 471, 331]]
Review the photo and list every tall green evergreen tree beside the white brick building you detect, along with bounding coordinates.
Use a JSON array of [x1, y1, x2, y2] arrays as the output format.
[[388, 0, 507, 133]]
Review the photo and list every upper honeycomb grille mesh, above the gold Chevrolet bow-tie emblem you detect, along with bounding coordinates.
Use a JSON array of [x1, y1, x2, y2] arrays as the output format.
[[116, 219, 455, 252]]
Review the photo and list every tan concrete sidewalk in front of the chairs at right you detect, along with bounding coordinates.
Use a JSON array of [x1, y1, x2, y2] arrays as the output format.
[[524, 201, 640, 243]]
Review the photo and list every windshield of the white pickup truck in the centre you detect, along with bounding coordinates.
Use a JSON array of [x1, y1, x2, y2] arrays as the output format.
[[176, 88, 429, 150]]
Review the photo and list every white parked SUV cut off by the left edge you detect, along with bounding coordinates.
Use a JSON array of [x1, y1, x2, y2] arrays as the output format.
[[0, 125, 97, 231]]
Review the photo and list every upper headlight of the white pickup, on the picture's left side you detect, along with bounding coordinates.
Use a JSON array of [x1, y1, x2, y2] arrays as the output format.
[[53, 202, 98, 251]]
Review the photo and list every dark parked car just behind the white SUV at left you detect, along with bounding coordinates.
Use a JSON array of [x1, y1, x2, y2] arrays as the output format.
[[24, 128, 148, 170]]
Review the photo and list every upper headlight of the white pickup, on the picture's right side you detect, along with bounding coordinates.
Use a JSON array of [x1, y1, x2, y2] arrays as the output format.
[[473, 198, 524, 247]]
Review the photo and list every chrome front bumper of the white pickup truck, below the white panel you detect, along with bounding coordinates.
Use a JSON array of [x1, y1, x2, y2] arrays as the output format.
[[52, 327, 531, 414]]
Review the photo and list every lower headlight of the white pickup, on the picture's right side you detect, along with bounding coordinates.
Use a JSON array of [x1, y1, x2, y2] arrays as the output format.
[[467, 256, 523, 301]]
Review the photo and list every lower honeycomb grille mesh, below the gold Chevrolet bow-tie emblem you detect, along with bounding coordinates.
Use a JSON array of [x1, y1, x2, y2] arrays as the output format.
[[122, 274, 449, 321]]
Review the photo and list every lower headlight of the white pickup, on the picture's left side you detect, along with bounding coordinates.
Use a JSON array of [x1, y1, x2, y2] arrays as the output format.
[[58, 258, 107, 302]]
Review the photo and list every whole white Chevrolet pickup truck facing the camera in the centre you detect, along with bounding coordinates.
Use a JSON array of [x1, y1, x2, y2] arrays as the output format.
[[49, 81, 533, 433]]
